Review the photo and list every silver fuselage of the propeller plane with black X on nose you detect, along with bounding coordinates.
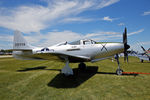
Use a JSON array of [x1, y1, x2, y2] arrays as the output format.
[[13, 42, 124, 62]]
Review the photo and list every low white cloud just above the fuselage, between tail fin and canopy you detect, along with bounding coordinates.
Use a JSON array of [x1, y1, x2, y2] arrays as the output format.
[[26, 30, 83, 47]]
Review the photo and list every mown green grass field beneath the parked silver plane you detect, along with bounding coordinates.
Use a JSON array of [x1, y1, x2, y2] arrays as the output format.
[[0, 57, 150, 100]]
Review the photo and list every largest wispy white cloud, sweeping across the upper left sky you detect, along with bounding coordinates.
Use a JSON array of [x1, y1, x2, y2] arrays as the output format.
[[0, 0, 119, 33]]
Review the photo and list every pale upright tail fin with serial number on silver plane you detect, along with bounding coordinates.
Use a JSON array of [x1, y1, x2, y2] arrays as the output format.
[[13, 30, 32, 50]]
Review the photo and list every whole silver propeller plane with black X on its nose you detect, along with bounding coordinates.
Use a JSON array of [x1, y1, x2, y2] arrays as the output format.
[[13, 28, 130, 75]]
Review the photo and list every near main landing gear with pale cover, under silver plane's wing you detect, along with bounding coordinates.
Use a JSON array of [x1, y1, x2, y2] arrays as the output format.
[[61, 58, 73, 76]]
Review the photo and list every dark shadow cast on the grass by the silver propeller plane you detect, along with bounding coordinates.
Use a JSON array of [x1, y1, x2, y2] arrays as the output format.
[[18, 66, 138, 88]]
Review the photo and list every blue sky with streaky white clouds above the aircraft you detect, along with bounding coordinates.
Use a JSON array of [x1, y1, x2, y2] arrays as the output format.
[[0, 0, 150, 51]]
